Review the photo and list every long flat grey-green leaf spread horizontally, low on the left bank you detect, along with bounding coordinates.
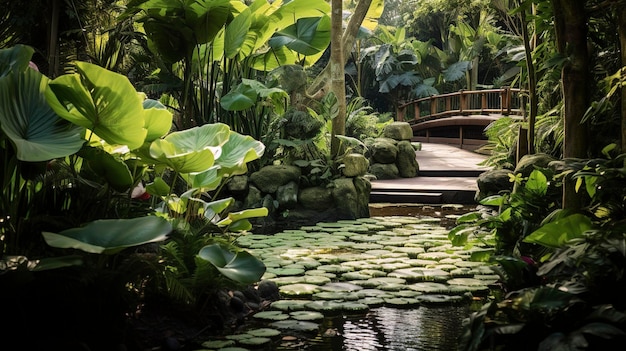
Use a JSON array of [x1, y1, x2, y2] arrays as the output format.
[[42, 216, 172, 254]]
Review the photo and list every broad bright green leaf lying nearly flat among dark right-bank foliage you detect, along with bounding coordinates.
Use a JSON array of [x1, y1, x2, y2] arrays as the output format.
[[524, 214, 593, 249]]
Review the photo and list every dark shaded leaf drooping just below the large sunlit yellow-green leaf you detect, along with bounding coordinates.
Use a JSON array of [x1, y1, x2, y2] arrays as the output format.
[[78, 147, 135, 192]]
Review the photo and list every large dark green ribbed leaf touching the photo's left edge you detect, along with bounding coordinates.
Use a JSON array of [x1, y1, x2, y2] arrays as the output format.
[[0, 69, 85, 162]]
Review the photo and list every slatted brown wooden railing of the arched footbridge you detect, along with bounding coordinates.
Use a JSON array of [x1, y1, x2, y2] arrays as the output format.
[[397, 87, 524, 124]]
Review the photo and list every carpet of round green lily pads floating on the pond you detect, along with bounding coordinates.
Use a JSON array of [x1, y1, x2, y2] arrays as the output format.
[[203, 216, 499, 351]]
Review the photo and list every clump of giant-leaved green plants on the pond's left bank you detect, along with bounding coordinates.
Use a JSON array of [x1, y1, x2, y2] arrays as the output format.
[[0, 46, 267, 350]]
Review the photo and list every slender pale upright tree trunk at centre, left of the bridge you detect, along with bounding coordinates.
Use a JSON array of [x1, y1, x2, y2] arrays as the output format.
[[330, 0, 346, 157]]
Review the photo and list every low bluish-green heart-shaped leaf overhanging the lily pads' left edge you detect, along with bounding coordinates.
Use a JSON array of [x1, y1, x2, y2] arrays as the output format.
[[198, 244, 265, 285]]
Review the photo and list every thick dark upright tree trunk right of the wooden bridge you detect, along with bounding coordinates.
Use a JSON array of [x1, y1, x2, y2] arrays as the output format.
[[552, 0, 590, 210]]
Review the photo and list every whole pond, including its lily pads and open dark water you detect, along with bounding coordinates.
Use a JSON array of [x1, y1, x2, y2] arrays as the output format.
[[197, 206, 499, 351]]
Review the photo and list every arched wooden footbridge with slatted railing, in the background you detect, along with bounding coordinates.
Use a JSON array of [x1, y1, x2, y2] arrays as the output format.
[[397, 87, 526, 150]]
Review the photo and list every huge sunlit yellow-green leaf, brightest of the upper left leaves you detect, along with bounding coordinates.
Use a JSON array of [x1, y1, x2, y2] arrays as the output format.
[[45, 62, 147, 150]]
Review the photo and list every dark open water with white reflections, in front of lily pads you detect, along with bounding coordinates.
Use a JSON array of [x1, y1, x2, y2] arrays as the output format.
[[290, 306, 469, 351]]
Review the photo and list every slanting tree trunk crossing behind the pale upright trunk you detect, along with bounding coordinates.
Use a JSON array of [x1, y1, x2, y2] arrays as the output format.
[[307, 0, 372, 96]]
